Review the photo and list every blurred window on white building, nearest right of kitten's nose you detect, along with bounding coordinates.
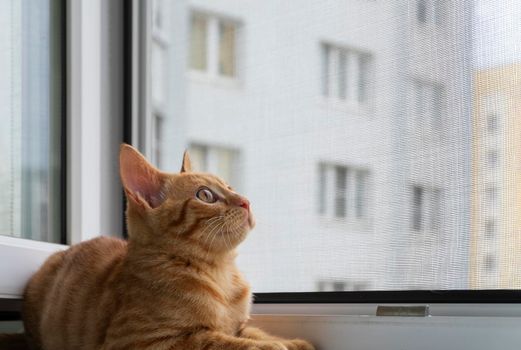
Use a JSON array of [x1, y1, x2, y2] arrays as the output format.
[[319, 164, 369, 220]]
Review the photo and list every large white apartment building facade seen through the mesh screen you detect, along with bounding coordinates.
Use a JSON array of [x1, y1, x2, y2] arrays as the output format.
[[150, 0, 472, 292]]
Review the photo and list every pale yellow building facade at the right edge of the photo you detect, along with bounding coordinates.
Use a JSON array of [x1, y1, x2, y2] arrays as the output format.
[[470, 63, 521, 289]]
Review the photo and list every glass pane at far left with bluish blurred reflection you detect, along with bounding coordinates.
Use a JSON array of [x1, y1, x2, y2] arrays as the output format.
[[0, 0, 65, 242]]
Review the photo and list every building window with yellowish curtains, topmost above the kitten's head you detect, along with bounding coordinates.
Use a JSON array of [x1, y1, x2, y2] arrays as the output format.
[[189, 12, 238, 78]]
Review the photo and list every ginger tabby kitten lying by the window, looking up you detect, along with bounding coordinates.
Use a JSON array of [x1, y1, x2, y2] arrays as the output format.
[[23, 145, 313, 350]]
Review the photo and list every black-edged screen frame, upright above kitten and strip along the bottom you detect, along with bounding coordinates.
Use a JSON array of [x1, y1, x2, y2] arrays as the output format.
[[122, 0, 521, 304]]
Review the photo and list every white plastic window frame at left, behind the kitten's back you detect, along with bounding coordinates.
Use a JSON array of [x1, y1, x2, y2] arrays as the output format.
[[0, 0, 122, 300]]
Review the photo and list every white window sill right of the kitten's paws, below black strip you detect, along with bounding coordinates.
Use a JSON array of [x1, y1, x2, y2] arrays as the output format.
[[251, 304, 521, 350]]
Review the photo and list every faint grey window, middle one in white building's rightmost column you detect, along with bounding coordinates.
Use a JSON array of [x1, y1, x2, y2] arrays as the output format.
[[413, 80, 443, 132]]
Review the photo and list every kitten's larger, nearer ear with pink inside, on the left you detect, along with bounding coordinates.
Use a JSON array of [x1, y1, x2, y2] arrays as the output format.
[[119, 144, 165, 208]]
